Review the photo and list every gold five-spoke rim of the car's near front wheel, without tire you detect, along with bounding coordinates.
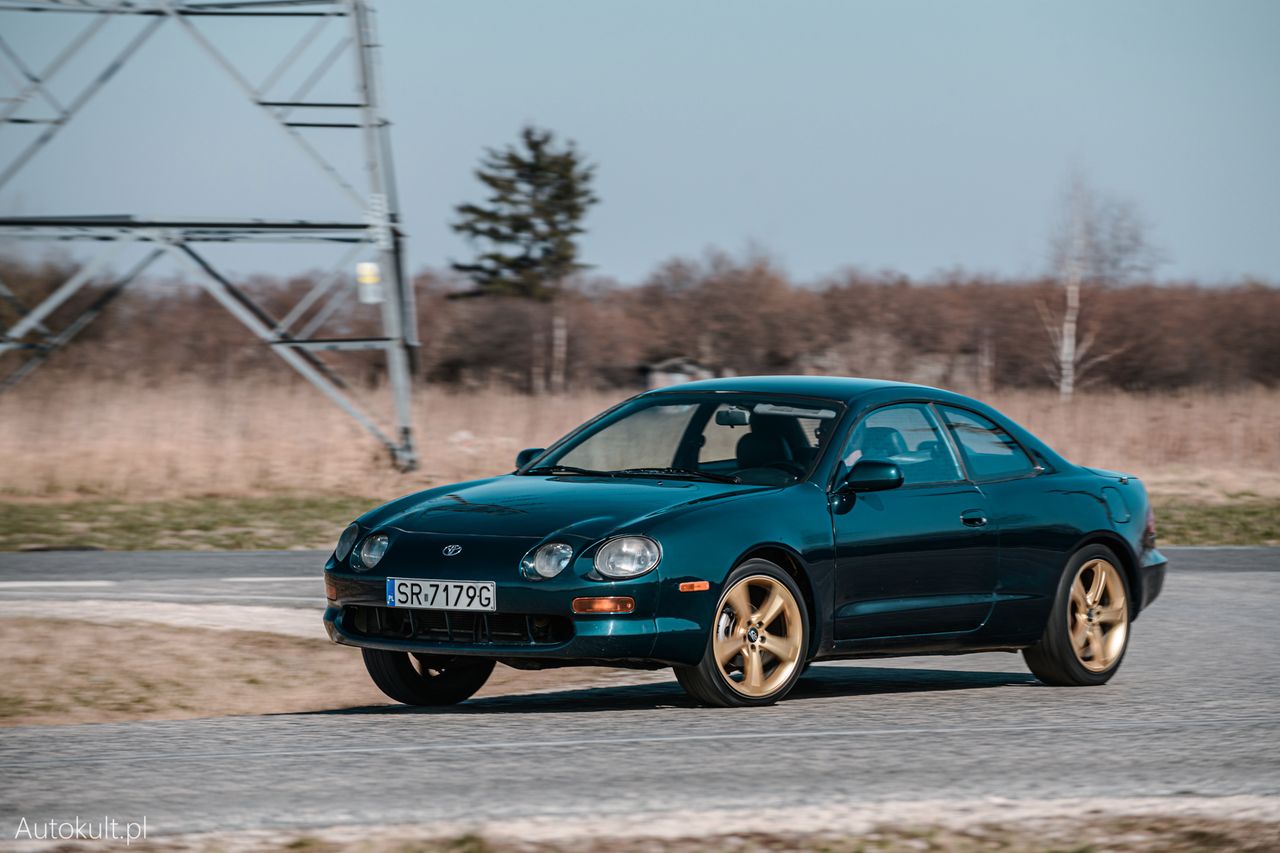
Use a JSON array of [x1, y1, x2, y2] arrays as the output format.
[[714, 575, 804, 697]]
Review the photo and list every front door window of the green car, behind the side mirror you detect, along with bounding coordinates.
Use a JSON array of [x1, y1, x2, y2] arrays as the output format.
[[841, 403, 963, 485]]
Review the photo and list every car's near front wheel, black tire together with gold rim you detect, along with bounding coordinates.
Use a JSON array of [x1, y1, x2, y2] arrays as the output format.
[[675, 550, 809, 708]]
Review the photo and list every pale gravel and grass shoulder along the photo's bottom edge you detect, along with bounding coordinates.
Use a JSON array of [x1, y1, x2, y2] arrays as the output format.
[[0, 797, 1280, 853]]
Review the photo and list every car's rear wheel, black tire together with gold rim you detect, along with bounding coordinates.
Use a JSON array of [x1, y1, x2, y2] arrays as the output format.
[[1023, 546, 1133, 686]]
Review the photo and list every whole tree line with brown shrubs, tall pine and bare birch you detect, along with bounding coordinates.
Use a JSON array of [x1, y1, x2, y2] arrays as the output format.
[[0, 127, 1280, 398]]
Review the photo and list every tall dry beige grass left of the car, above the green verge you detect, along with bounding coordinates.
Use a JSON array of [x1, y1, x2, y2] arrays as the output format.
[[0, 380, 623, 501]]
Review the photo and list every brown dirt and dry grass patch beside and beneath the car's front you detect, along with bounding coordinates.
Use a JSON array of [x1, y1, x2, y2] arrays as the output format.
[[0, 619, 664, 726]]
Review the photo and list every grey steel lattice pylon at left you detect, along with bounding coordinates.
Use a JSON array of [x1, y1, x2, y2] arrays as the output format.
[[0, 0, 419, 470]]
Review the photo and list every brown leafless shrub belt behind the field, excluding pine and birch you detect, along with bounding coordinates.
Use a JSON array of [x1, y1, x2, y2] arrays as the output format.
[[0, 252, 1280, 392]]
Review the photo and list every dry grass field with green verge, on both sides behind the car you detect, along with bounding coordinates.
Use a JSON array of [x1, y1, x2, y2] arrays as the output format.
[[0, 380, 1280, 547]]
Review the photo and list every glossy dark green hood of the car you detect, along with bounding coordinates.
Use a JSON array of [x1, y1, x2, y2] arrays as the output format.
[[361, 475, 776, 539]]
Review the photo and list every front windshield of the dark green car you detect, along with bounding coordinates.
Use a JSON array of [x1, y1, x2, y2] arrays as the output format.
[[524, 393, 842, 485]]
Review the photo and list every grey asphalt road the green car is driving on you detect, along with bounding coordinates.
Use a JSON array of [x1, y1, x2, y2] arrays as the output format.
[[0, 549, 1280, 838]]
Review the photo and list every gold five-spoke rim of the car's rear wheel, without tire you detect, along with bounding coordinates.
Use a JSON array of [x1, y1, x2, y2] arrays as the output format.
[[1066, 560, 1129, 672]]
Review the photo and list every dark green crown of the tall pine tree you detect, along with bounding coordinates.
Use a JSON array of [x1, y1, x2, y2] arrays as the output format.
[[453, 127, 598, 301]]
